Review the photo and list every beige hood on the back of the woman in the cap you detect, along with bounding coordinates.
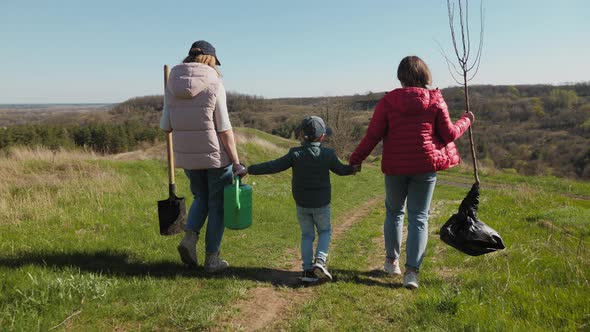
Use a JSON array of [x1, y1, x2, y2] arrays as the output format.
[[168, 62, 219, 99]]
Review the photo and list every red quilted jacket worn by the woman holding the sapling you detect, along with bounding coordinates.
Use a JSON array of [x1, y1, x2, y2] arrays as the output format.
[[349, 87, 471, 175]]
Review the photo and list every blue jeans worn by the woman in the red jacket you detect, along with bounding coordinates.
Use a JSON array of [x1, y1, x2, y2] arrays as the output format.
[[383, 172, 436, 271]]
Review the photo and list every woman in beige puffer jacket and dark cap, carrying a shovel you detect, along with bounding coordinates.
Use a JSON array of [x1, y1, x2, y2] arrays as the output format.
[[160, 40, 245, 272]]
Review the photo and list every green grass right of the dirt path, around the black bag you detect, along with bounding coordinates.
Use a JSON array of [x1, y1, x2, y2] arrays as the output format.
[[282, 185, 590, 331]]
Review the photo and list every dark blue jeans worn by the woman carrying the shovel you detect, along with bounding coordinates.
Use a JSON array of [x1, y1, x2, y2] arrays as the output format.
[[184, 165, 232, 253]]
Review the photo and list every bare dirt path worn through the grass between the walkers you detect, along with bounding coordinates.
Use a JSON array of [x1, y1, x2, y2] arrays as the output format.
[[221, 196, 384, 331]]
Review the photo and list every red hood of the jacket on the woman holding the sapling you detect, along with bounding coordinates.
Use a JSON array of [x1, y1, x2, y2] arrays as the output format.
[[384, 87, 442, 112]]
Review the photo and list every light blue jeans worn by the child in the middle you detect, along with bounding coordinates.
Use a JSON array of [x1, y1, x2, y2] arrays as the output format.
[[297, 204, 332, 270]]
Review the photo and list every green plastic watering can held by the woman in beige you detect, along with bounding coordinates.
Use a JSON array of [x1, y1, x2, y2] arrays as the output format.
[[223, 176, 252, 230]]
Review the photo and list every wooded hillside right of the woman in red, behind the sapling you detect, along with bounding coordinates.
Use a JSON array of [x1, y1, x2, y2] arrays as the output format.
[[443, 83, 590, 179]]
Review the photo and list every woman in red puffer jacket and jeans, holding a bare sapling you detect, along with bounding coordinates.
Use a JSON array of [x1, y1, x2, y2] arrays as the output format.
[[350, 56, 473, 288]]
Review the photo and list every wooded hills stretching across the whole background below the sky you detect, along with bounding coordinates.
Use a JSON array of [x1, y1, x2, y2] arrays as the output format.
[[0, 83, 590, 179]]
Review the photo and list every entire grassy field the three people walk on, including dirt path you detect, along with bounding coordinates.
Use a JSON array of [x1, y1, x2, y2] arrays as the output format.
[[0, 129, 590, 331]]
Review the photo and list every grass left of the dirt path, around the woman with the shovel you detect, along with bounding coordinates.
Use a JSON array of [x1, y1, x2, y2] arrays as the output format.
[[0, 130, 382, 330]]
